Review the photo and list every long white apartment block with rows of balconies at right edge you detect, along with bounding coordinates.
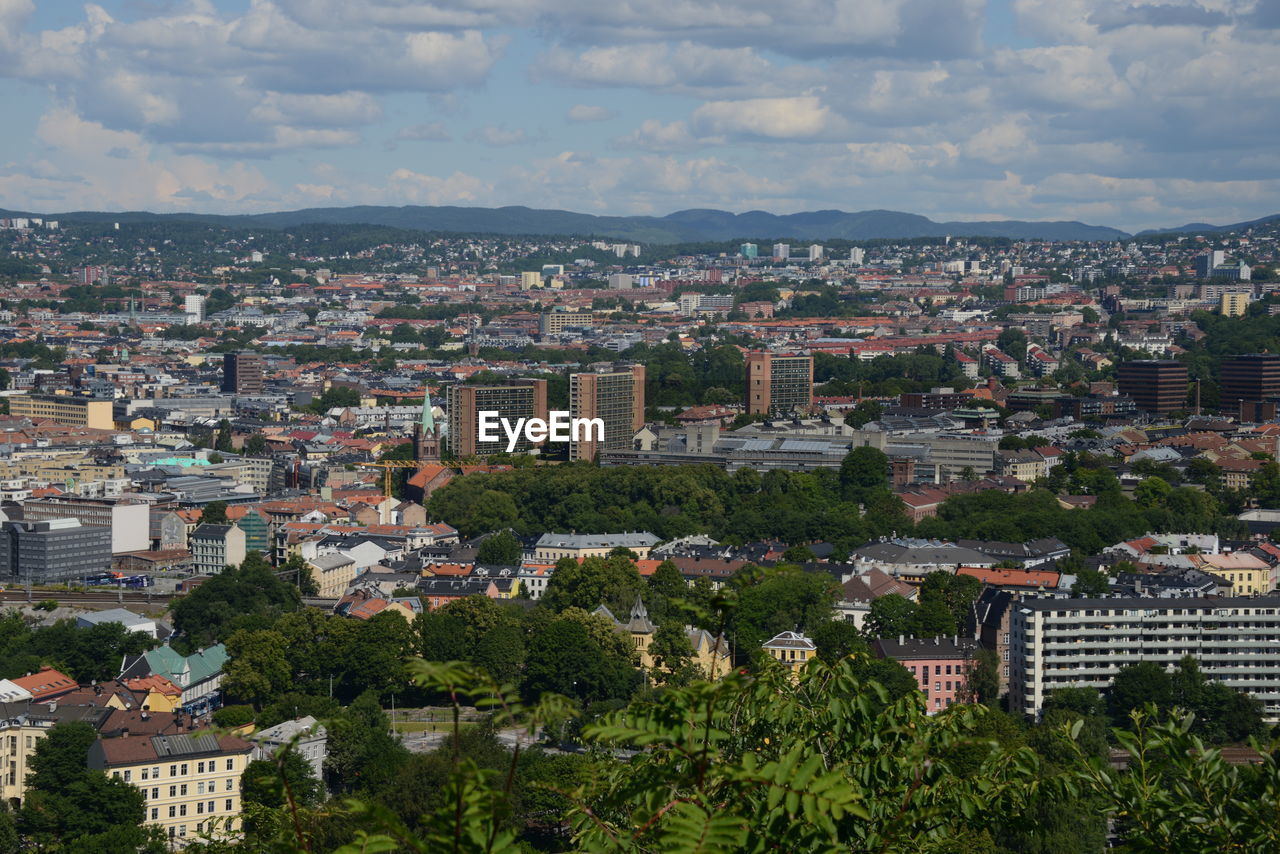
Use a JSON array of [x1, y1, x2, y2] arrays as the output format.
[[1009, 597, 1280, 721]]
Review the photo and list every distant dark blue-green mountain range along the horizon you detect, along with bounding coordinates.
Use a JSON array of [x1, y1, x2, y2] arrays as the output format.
[[0, 205, 1280, 243]]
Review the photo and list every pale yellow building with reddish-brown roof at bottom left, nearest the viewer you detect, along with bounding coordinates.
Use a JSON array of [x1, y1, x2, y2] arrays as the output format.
[[88, 732, 253, 844]]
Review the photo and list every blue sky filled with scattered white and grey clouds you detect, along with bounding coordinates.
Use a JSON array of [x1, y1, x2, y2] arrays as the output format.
[[0, 0, 1280, 230]]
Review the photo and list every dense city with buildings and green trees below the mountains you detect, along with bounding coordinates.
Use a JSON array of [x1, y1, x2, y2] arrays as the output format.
[[0, 208, 1280, 854]]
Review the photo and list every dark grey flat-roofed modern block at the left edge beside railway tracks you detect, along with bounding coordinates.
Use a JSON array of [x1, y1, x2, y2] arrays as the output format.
[[0, 519, 111, 584]]
